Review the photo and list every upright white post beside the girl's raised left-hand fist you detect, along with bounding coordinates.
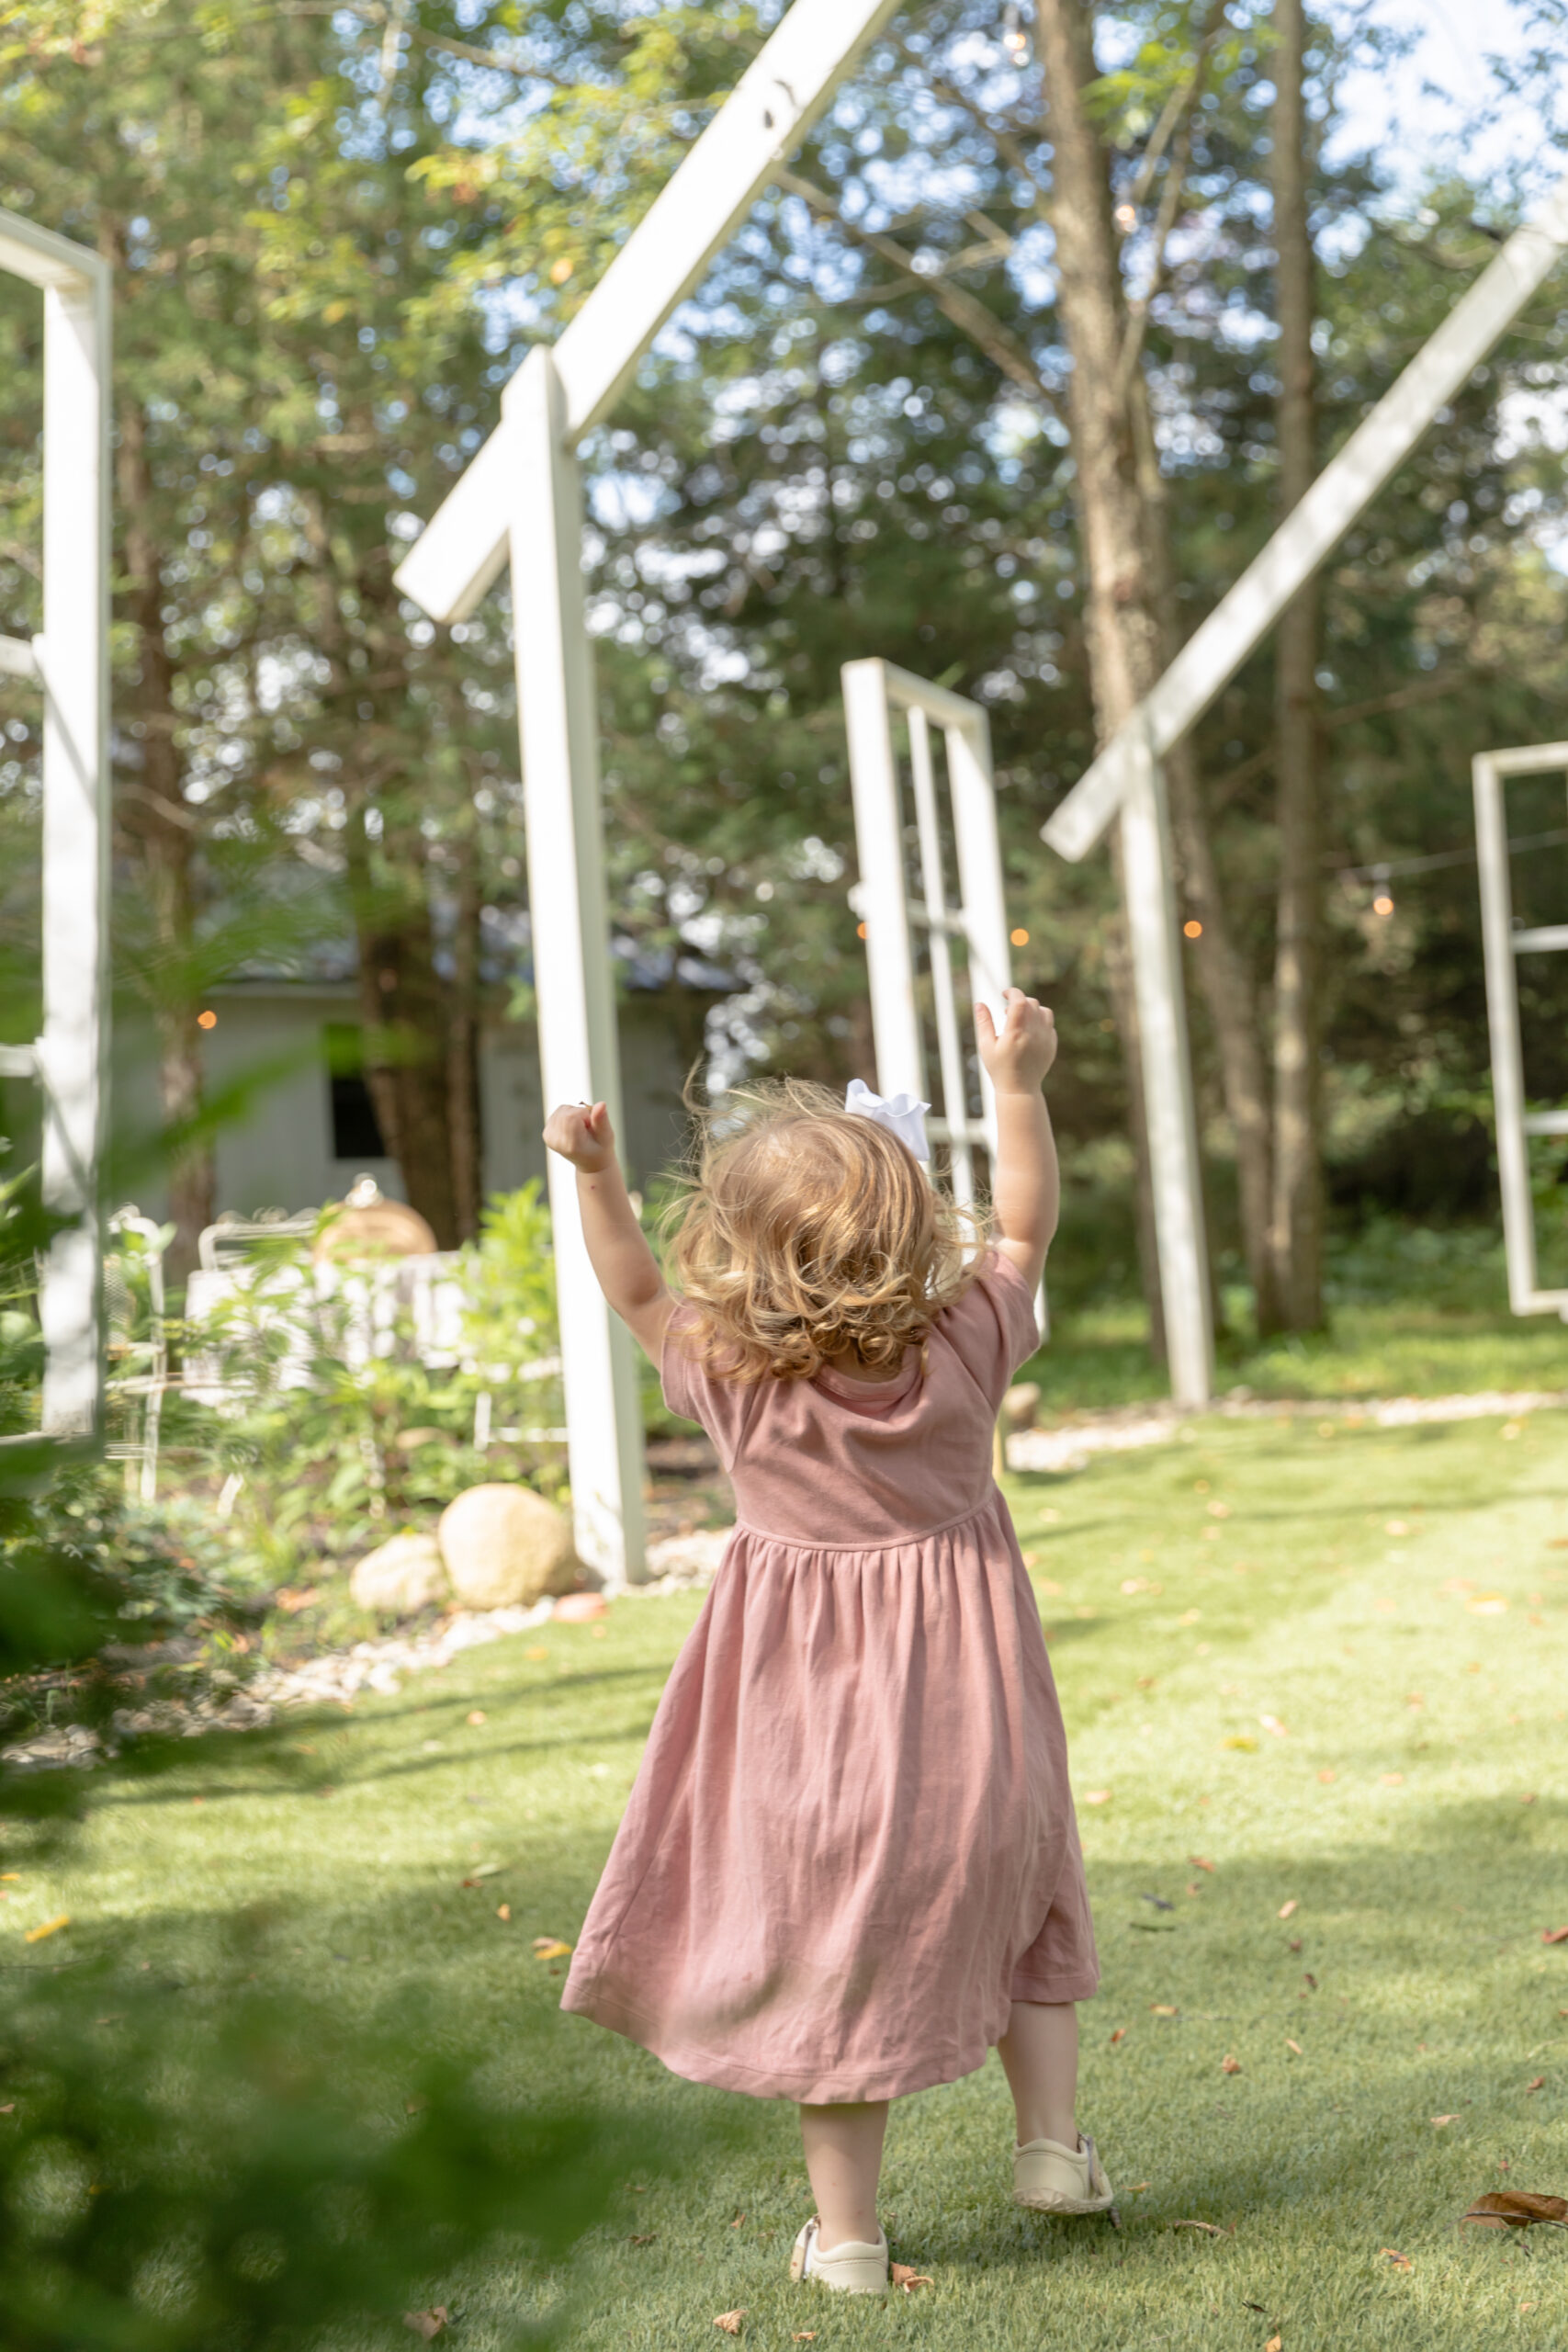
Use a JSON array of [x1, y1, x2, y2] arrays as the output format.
[[508, 345, 644, 1583]]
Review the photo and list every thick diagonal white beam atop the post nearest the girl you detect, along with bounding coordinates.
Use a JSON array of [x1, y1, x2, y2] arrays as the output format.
[[398, 0, 896, 621]]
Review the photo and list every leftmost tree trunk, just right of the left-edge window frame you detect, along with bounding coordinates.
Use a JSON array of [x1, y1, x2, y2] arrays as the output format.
[[115, 400, 214, 1286]]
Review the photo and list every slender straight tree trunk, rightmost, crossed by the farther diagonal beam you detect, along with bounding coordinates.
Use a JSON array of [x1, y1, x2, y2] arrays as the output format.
[[1269, 0, 1324, 1331]]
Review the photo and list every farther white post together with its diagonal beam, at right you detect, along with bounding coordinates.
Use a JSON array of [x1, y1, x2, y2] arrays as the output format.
[[1042, 179, 1568, 1404]]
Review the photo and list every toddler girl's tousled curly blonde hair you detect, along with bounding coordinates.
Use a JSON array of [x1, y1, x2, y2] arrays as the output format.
[[668, 1080, 985, 1381]]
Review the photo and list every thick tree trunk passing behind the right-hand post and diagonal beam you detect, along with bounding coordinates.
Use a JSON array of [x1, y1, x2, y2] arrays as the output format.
[[1034, 0, 1164, 1355]]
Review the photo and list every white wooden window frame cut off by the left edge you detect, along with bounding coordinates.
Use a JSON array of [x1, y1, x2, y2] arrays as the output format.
[[0, 211, 110, 1437]]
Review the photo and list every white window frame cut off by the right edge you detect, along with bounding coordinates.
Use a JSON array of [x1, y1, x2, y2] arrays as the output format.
[[1472, 743, 1568, 1319]]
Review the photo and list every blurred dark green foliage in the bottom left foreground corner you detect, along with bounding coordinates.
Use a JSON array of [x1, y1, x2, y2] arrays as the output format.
[[0, 1966, 651, 2352]]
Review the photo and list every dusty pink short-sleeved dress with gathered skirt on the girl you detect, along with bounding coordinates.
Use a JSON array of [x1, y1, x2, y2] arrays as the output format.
[[562, 1256, 1098, 2103]]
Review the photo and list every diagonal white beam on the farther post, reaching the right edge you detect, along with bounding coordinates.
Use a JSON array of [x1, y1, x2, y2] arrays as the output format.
[[1042, 179, 1568, 858]]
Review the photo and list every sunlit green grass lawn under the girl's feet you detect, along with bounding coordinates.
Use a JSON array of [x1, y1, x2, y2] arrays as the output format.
[[0, 1408, 1568, 2352]]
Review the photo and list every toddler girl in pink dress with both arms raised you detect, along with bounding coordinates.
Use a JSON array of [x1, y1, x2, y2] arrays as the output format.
[[546, 988, 1112, 2293]]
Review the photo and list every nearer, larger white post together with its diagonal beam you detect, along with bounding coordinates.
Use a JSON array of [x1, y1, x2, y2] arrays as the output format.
[[398, 0, 896, 1583]]
